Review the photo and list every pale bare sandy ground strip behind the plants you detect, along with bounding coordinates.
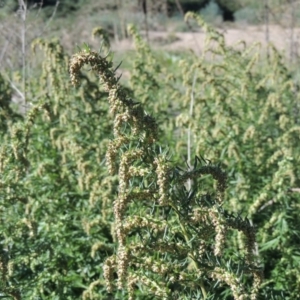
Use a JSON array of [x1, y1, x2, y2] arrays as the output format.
[[112, 25, 300, 55]]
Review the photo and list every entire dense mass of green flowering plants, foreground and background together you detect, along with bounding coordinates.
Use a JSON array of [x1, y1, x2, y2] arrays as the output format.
[[0, 13, 300, 300]]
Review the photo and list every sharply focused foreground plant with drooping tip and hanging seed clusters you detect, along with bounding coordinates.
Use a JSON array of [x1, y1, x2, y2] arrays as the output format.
[[70, 43, 261, 299]]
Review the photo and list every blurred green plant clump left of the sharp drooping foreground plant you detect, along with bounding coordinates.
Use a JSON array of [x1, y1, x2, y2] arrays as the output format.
[[0, 40, 114, 299]]
